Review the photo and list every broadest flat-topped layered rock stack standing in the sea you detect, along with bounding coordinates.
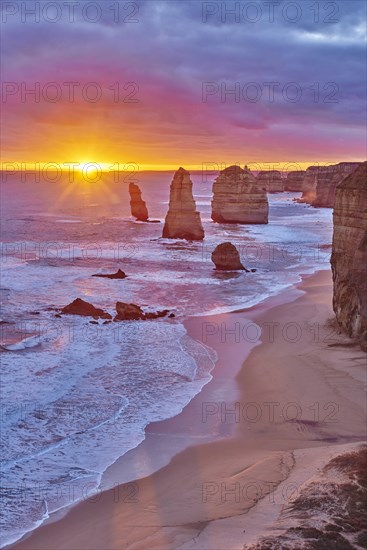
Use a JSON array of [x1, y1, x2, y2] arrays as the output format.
[[212, 165, 269, 224]]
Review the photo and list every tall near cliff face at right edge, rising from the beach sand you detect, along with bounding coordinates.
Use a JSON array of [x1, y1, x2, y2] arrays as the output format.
[[331, 162, 367, 351]]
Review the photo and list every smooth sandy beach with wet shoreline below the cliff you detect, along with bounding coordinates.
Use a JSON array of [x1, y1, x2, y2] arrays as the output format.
[[12, 271, 366, 550]]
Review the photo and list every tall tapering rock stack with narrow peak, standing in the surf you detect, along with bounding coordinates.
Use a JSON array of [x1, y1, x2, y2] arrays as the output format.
[[162, 168, 204, 241]]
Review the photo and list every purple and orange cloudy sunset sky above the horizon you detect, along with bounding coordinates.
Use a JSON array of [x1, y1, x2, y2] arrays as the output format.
[[1, 0, 367, 169]]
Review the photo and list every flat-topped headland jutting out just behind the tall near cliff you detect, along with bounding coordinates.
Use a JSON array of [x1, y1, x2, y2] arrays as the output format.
[[298, 162, 360, 208]]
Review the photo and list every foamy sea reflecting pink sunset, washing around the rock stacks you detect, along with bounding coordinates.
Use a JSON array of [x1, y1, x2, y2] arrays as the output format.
[[0, 172, 332, 546]]
